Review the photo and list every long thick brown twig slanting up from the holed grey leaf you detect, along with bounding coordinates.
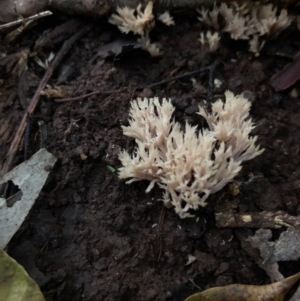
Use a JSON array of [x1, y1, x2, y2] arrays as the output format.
[[0, 26, 91, 176]]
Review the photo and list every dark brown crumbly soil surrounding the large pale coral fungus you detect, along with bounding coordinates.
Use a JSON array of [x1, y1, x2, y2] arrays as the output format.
[[0, 10, 300, 301]]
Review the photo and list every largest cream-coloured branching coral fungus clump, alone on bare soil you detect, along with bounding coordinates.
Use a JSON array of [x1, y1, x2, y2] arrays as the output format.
[[119, 91, 263, 218]]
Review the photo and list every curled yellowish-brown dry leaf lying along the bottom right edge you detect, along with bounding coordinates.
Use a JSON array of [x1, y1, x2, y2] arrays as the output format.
[[185, 273, 300, 301]]
